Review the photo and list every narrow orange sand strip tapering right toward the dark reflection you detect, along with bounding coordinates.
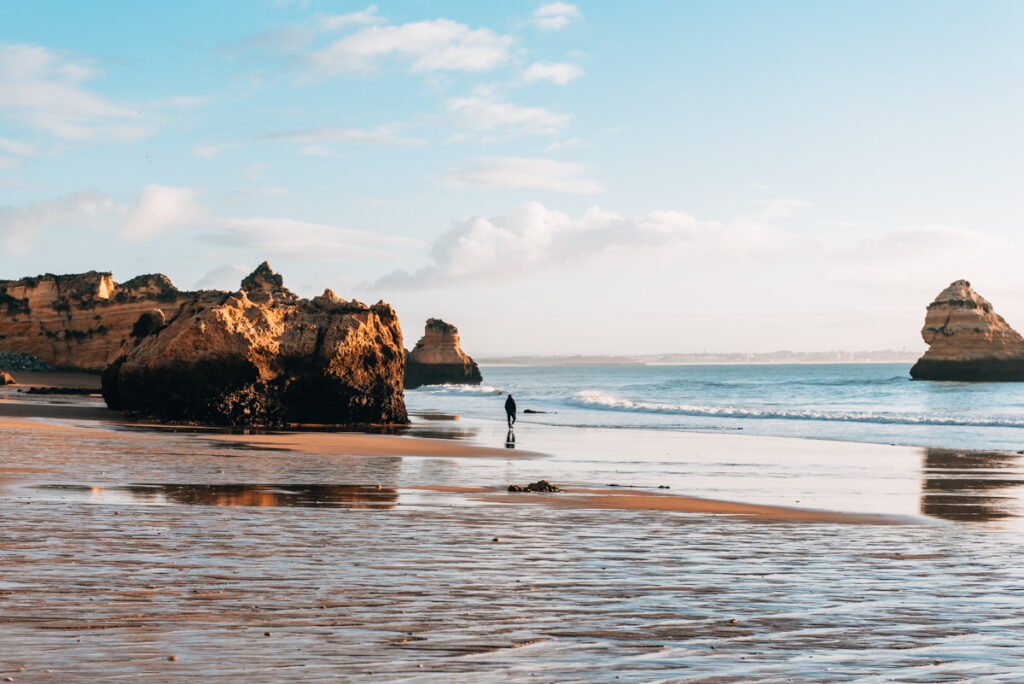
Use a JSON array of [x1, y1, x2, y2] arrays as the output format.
[[401, 486, 925, 525]]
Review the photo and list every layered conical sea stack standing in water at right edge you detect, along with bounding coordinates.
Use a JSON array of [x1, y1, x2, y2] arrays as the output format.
[[910, 281, 1024, 381]]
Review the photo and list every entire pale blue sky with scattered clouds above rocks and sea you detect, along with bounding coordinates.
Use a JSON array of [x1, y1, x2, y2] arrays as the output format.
[[0, 0, 1024, 356]]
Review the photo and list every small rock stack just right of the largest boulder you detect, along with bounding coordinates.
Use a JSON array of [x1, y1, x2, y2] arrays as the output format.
[[406, 318, 483, 389]]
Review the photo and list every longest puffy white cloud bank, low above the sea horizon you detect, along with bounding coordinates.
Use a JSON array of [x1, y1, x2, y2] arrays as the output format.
[[367, 202, 1020, 294]]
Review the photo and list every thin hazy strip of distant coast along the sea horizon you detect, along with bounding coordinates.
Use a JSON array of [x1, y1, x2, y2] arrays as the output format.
[[477, 349, 923, 366]]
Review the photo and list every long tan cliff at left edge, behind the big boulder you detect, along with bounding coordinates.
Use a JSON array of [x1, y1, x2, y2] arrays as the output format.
[[0, 270, 201, 371]]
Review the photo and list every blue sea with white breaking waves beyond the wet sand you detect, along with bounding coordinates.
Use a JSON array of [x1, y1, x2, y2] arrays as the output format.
[[406, 364, 1024, 452]]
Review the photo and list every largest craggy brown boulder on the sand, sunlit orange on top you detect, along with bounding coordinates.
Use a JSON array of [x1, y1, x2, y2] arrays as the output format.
[[102, 263, 408, 426]]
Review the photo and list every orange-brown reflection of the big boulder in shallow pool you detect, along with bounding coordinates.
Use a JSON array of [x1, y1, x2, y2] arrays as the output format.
[[32, 484, 398, 508]]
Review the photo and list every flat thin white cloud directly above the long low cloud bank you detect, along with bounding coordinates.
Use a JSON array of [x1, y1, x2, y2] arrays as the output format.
[[441, 157, 604, 195]]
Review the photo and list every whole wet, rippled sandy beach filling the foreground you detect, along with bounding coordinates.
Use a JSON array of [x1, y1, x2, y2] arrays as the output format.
[[0, 370, 1024, 682]]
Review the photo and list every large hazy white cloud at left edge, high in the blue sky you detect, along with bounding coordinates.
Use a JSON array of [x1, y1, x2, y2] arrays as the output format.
[[0, 44, 152, 141]]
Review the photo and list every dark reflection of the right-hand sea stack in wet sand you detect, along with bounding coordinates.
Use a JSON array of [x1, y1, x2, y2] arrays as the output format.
[[921, 448, 1024, 522]]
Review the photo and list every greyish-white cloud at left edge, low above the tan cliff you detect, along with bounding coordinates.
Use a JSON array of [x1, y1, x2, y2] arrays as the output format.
[[0, 193, 116, 255]]
